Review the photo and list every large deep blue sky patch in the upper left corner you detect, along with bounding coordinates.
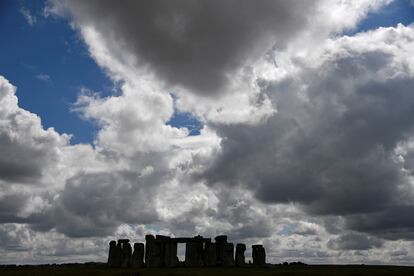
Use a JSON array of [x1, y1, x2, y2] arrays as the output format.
[[0, 0, 113, 143]]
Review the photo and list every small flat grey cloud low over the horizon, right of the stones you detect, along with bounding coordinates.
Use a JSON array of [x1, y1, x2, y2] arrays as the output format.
[[327, 233, 383, 250]]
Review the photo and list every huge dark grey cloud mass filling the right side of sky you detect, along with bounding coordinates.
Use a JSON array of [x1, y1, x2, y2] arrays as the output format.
[[201, 38, 414, 238]]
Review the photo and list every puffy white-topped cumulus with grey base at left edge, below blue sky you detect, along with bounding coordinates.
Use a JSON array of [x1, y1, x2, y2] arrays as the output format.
[[0, 76, 69, 183]]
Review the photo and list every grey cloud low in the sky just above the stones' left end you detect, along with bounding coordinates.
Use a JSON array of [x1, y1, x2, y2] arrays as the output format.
[[45, 171, 158, 237]]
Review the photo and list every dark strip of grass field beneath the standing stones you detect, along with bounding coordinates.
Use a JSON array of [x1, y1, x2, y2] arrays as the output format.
[[0, 265, 414, 276]]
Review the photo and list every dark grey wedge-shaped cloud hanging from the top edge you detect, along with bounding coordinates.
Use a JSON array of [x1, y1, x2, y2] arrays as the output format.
[[58, 0, 317, 94]]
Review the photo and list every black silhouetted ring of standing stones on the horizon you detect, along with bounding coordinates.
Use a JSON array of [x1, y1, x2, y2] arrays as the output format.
[[108, 235, 266, 267]]
